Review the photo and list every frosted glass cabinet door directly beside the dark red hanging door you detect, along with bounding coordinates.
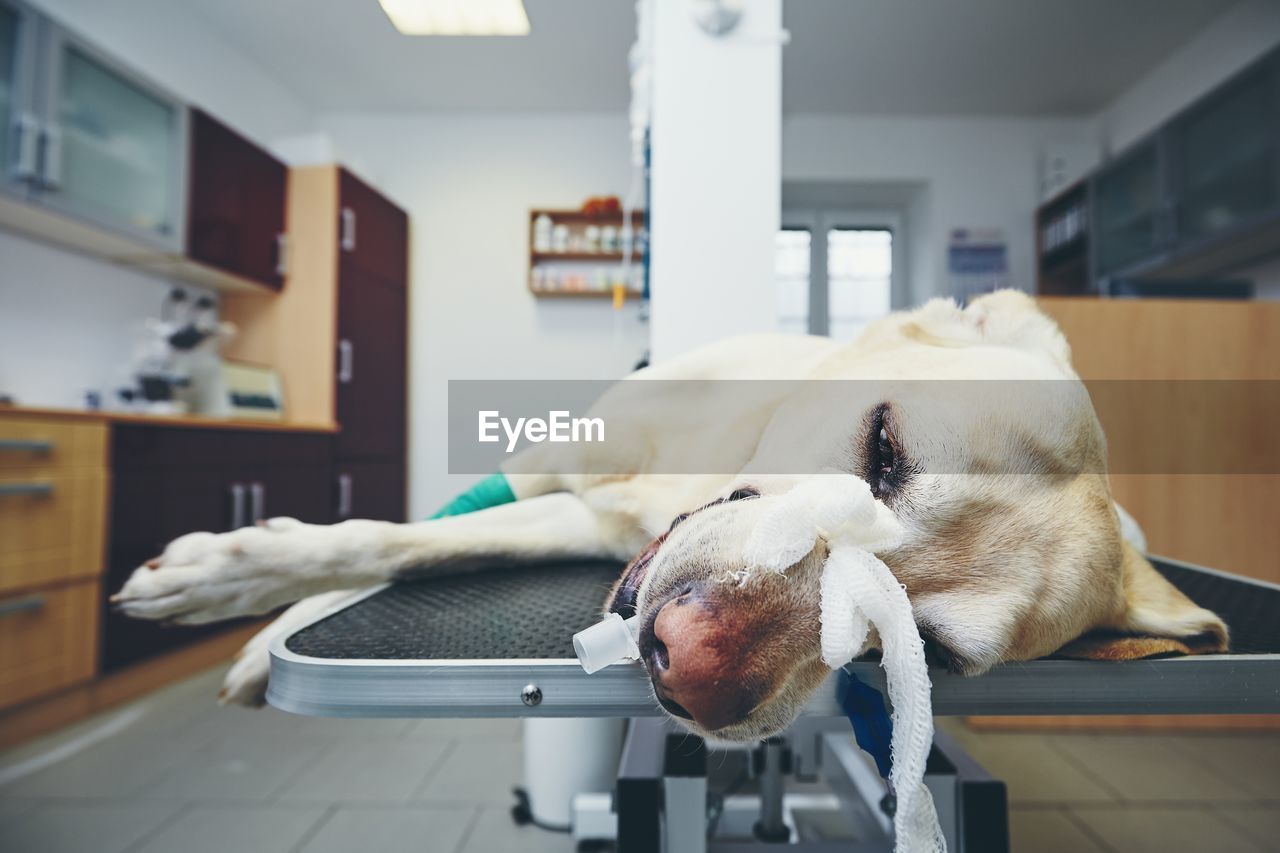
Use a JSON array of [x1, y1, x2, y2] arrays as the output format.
[[44, 33, 186, 245]]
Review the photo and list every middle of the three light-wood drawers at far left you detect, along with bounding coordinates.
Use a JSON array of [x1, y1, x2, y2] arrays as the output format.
[[0, 467, 108, 594]]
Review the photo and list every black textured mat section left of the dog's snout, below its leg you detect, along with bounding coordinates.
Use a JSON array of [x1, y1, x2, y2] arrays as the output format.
[[285, 562, 622, 661]]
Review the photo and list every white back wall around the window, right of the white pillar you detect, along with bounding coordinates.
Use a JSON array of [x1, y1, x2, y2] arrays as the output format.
[[782, 115, 1096, 302]]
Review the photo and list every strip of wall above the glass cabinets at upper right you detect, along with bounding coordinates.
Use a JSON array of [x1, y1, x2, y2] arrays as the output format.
[[1098, 0, 1280, 154]]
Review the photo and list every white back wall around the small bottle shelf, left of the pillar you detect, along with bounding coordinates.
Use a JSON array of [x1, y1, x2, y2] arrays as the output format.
[[320, 114, 648, 517]]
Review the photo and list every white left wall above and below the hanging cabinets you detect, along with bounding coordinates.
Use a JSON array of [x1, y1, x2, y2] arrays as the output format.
[[0, 0, 312, 406]]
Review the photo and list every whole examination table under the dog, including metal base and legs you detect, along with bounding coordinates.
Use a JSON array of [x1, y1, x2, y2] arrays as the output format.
[[268, 557, 1280, 853]]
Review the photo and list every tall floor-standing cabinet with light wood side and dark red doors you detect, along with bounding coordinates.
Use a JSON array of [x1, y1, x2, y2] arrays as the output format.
[[223, 165, 408, 521]]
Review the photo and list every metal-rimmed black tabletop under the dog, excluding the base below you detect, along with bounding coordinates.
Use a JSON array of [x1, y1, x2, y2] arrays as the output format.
[[268, 557, 1280, 717]]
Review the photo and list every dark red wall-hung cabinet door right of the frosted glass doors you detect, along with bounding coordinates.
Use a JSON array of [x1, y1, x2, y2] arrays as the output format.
[[187, 110, 288, 289]]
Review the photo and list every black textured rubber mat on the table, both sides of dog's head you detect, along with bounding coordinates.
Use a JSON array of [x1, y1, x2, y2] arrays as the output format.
[[285, 561, 1280, 661]]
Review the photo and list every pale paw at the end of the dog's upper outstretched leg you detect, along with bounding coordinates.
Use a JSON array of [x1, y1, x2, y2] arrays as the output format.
[[111, 519, 326, 625]]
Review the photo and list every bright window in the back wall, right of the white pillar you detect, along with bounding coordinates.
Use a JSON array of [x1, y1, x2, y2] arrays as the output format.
[[774, 211, 900, 341]]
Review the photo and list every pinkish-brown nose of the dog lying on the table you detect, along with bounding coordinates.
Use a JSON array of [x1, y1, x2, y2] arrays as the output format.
[[640, 587, 756, 731]]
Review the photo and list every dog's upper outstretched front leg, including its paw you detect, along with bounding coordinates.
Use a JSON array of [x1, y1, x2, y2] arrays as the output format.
[[111, 493, 623, 625]]
